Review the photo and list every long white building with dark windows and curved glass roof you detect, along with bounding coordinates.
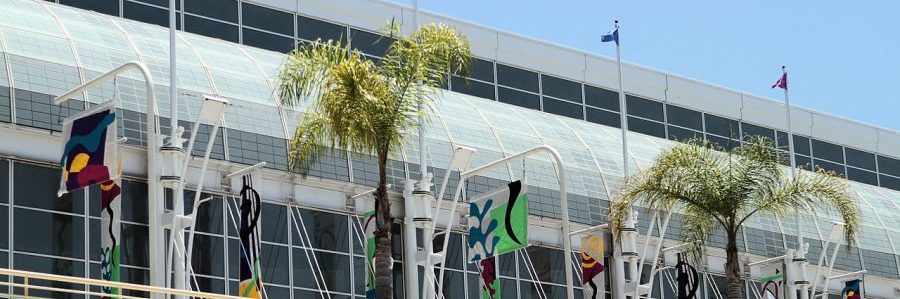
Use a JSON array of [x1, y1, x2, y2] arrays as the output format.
[[0, 0, 900, 298]]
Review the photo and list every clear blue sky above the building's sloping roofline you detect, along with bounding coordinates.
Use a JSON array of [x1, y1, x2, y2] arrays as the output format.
[[391, 0, 900, 130]]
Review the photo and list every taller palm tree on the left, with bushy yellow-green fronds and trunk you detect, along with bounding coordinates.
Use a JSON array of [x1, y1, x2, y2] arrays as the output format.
[[278, 24, 471, 298]]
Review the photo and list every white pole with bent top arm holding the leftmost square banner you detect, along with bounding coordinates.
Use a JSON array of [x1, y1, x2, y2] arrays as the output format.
[[53, 61, 165, 298]]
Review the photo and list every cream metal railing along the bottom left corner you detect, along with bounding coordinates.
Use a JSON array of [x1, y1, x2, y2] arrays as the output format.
[[0, 268, 244, 299]]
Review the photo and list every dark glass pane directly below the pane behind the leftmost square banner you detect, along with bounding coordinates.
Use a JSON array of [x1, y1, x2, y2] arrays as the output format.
[[13, 208, 84, 258]]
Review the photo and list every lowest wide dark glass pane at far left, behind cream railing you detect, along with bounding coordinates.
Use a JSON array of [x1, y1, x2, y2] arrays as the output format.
[[13, 254, 84, 299]]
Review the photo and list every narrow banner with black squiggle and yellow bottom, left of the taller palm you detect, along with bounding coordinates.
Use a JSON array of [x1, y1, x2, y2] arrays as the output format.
[[238, 174, 265, 299]]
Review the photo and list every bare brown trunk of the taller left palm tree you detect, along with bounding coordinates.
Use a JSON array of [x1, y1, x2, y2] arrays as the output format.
[[374, 150, 394, 299]]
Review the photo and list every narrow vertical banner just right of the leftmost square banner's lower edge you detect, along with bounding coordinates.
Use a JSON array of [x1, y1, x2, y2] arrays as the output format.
[[100, 180, 122, 298]]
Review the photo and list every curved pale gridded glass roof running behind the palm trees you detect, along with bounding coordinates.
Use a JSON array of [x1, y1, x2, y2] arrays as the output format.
[[0, 0, 900, 278]]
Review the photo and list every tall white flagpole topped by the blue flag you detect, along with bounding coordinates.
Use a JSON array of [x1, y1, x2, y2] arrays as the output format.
[[613, 20, 637, 299]]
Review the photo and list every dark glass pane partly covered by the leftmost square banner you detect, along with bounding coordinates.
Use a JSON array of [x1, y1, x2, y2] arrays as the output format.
[[13, 163, 84, 214]]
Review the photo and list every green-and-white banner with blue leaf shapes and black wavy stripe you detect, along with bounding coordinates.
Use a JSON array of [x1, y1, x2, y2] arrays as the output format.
[[468, 181, 528, 262]]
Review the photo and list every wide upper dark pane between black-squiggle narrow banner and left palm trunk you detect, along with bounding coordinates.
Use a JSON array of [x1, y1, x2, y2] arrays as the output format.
[[292, 209, 349, 252]]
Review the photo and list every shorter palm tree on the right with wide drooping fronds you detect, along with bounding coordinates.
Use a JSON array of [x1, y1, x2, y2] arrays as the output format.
[[609, 138, 859, 299]]
